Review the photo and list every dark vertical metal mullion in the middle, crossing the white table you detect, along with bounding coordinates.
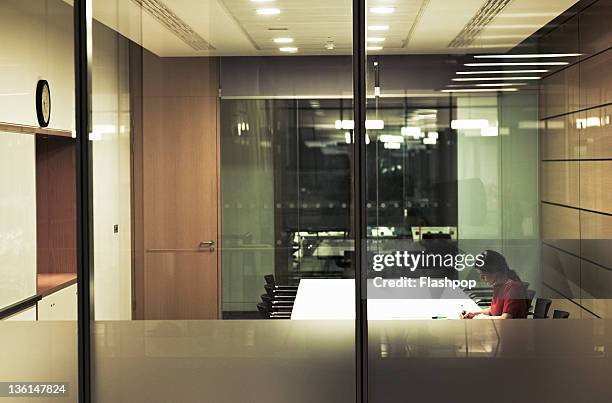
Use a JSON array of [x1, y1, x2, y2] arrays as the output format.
[[352, 0, 368, 403]]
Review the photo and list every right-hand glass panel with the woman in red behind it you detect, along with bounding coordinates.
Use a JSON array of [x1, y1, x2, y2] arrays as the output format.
[[363, 0, 612, 402]]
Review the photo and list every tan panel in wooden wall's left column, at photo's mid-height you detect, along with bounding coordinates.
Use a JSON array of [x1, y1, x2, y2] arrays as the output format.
[[540, 161, 579, 207]]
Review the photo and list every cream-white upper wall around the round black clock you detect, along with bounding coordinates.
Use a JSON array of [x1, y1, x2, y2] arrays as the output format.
[[0, 0, 74, 130]]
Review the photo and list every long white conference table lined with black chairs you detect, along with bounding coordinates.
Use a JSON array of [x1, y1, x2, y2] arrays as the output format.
[[291, 279, 481, 320]]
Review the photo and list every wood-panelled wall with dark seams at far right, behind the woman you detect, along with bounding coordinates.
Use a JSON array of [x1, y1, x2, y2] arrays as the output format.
[[539, 0, 612, 317]]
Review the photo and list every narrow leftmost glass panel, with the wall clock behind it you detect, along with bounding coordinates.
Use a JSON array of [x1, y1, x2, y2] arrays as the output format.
[[0, 0, 78, 402]]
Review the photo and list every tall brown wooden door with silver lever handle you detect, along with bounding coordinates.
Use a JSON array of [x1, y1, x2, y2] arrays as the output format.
[[136, 53, 219, 319]]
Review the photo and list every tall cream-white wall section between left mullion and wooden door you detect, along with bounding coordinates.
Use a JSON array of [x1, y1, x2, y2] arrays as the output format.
[[92, 22, 132, 320]]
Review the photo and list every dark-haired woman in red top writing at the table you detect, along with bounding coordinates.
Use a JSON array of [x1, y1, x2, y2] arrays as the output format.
[[461, 250, 529, 319]]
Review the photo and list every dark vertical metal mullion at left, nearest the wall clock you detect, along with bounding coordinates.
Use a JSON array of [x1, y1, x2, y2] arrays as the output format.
[[74, 0, 93, 403]]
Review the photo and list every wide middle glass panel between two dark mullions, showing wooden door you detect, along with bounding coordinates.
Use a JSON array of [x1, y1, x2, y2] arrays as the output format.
[[91, 0, 355, 403]]
